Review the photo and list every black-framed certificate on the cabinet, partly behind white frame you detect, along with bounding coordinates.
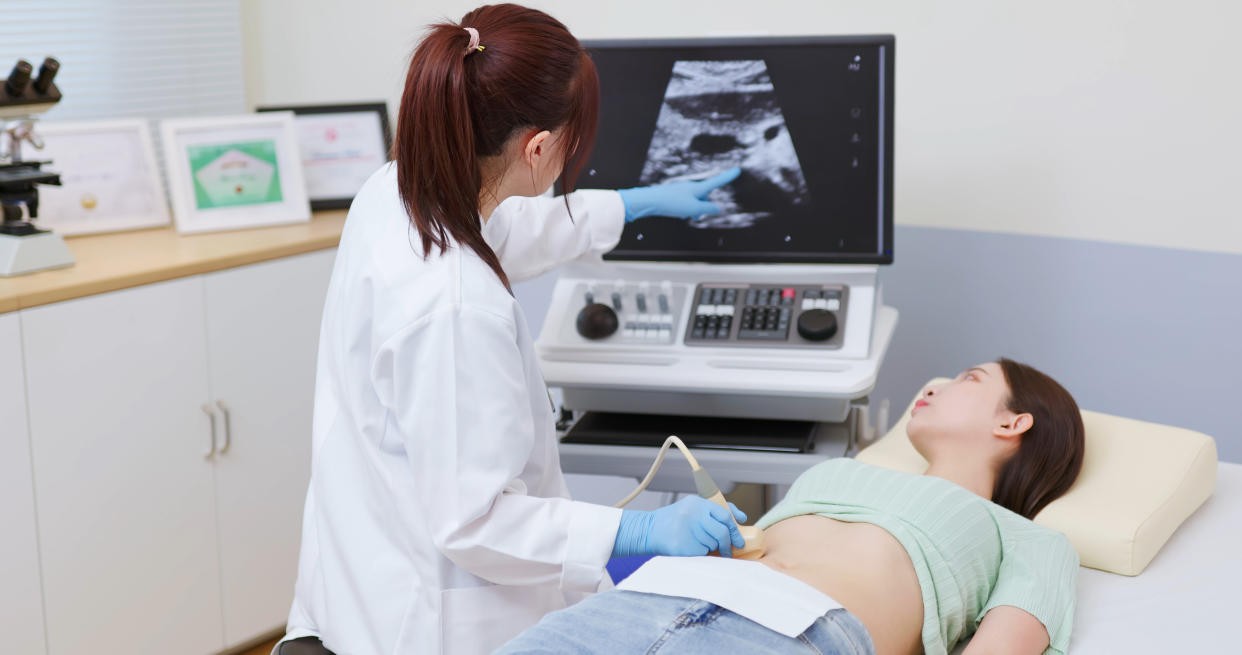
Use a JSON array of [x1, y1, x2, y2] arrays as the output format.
[[256, 102, 392, 210]]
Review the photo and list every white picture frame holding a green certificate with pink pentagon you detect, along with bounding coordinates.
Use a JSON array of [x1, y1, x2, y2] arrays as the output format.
[[160, 112, 311, 234]]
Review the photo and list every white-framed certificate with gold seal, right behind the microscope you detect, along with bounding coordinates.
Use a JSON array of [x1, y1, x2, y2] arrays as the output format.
[[35, 118, 171, 236]]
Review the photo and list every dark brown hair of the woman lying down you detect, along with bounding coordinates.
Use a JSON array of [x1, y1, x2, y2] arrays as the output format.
[[992, 357, 1086, 518]]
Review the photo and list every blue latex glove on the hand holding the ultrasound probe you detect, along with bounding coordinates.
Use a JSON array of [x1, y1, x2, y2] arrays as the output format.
[[612, 496, 746, 557]]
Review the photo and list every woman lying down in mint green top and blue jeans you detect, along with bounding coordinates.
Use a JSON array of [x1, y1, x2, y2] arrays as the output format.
[[497, 359, 1083, 655]]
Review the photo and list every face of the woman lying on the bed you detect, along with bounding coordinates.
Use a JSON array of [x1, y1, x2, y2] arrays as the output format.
[[905, 362, 1011, 460]]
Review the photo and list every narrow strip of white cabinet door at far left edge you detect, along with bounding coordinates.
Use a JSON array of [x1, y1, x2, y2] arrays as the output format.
[[0, 313, 47, 653]]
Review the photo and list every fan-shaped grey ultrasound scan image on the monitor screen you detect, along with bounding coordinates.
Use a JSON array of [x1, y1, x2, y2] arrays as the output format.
[[640, 60, 810, 227]]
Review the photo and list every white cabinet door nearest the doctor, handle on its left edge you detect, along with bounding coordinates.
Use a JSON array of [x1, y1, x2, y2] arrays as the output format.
[[205, 250, 335, 646]]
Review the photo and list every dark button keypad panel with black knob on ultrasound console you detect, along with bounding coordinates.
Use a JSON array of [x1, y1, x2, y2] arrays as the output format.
[[686, 283, 850, 349]]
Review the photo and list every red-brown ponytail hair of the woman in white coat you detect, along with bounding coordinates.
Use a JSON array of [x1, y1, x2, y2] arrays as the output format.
[[392, 4, 600, 287]]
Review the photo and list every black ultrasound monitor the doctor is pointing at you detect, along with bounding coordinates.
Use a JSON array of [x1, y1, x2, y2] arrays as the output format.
[[579, 35, 894, 263]]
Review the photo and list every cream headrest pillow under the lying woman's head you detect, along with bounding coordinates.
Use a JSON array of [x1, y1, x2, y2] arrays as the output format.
[[857, 378, 1216, 575]]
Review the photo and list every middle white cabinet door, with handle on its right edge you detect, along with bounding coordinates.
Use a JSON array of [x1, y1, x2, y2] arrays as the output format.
[[21, 277, 224, 655]]
